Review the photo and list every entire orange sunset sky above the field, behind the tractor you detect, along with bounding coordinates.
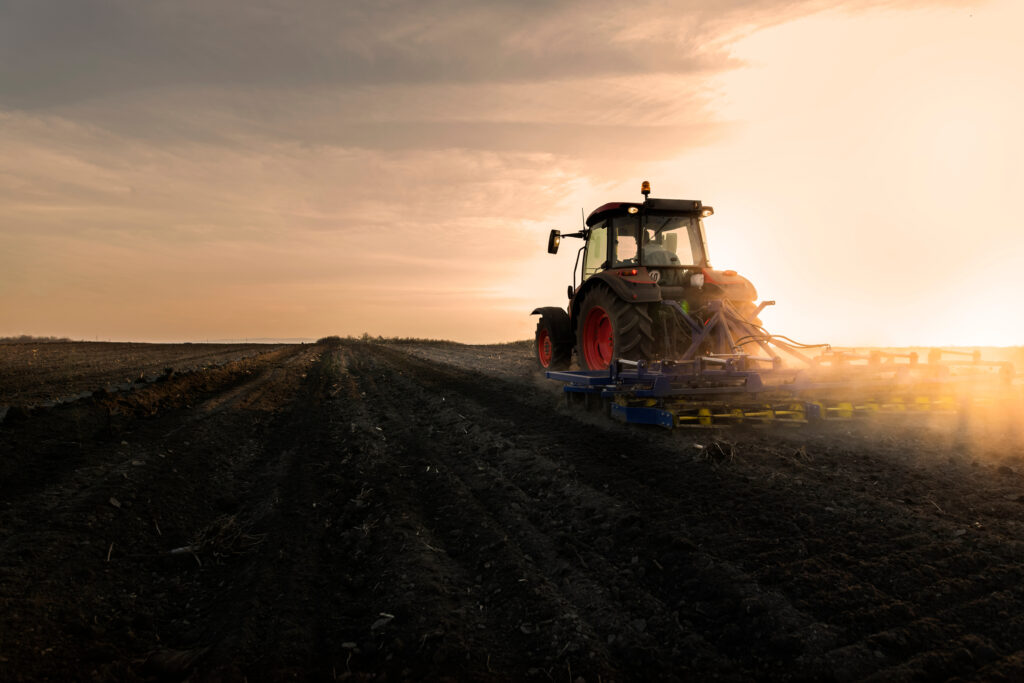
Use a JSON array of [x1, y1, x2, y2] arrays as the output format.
[[0, 0, 1024, 345]]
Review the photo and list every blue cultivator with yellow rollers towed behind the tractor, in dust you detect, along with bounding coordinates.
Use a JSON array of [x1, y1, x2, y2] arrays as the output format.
[[547, 350, 1021, 428]]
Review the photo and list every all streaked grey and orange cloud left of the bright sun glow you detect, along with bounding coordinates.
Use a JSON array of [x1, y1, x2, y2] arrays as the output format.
[[0, 0, 978, 340]]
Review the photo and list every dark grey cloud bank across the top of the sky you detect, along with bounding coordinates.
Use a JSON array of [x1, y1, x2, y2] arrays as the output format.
[[0, 0, 966, 158]]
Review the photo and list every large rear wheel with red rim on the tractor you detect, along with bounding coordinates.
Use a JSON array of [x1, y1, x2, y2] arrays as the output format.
[[577, 286, 654, 370]]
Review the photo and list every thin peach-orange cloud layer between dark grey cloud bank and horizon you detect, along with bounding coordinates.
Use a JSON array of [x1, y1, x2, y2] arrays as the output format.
[[0, 101, 583, 339]]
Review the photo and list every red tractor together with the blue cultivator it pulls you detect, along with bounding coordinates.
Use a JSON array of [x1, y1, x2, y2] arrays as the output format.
[[532, 181, 1024, 428]]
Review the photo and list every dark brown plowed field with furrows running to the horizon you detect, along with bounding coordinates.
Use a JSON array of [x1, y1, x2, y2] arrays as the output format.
[[0, 342, 1024, 682]]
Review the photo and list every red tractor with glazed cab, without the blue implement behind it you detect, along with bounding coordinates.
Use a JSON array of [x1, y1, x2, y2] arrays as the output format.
[[532, 181, 771, 371]]
